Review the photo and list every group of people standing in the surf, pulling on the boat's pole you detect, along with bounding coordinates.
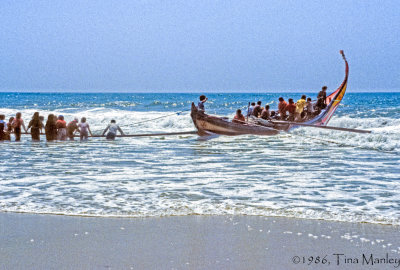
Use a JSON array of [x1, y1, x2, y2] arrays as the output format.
[[0, 112, 124, 141]]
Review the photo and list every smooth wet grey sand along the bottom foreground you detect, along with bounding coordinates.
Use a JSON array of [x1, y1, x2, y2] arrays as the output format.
[[0, 213, 400, 269]]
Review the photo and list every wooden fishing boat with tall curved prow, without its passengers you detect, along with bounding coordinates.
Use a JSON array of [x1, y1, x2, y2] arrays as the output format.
[[190, 51, 349, 136]]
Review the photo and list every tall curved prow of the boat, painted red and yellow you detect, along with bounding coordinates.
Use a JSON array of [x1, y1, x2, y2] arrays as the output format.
[[315, 50, 349, 126]]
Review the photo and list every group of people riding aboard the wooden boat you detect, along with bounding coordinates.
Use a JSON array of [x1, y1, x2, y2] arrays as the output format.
[[197, 86, 327, 123]]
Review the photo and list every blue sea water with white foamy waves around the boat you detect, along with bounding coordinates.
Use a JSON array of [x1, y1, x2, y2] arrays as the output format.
[[0, 93, 400, 225]]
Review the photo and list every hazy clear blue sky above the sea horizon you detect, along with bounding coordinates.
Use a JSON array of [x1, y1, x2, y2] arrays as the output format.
[[0, 0, 400, 92]]
